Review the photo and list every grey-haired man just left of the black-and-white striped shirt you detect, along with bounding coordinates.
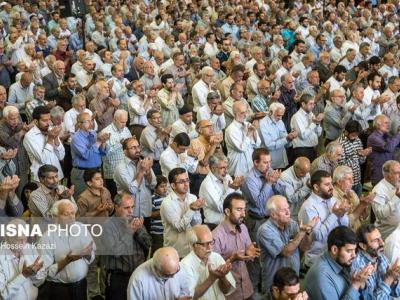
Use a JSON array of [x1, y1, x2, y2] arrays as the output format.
[[311, 141, 343, 175]]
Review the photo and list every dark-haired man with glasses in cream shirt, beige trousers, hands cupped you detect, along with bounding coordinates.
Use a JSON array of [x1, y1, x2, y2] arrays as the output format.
[[160, 168, 205, 258]]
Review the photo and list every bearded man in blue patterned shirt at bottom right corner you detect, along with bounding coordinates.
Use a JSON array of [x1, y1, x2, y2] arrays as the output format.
[[351, 224, 400, 299]]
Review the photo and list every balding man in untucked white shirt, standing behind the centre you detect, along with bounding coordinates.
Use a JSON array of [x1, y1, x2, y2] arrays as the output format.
[[225, 101, 261, 176]]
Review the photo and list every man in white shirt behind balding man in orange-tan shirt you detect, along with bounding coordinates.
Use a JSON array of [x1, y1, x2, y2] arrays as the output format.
[[197, 91, 226, 132]]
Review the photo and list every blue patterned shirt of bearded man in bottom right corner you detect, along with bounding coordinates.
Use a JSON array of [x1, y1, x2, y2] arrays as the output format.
[[351, 250, 400, 300]]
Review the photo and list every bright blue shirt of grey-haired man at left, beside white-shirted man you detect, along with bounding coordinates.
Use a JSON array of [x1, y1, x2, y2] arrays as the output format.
[[71, 130, 109, 169]]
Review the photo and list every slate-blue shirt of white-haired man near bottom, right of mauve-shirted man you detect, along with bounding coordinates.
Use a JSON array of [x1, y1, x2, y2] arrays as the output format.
[[257, 218, 300, 293]]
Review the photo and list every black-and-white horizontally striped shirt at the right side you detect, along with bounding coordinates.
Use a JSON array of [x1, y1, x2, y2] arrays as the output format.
[[338, 133, 365, 185]]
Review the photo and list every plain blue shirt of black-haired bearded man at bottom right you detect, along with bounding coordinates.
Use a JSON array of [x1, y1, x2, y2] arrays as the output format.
[[304, 252, 360, 300]]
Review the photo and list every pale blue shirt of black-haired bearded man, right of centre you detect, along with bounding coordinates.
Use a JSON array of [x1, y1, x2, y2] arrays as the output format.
[[298, 193, 349, 266]]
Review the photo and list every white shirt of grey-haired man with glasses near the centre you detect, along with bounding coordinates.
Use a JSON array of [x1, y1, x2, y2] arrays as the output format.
[[199, 172, 235, 224]]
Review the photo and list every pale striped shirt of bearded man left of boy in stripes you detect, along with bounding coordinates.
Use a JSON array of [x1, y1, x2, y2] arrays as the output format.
[[114, 156, 157, 217]]
